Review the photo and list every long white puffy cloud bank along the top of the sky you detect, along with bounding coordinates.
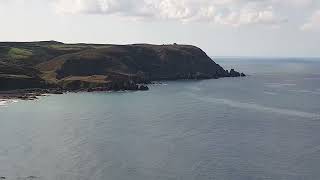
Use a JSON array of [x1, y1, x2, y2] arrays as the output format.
[[54, 0, 296, 26]]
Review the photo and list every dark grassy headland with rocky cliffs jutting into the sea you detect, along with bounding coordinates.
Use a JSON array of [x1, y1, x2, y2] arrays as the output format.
[[0, 42, 244, 90]]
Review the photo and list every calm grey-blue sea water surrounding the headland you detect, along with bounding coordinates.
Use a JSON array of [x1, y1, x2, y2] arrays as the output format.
[[0, 58, 320, 180]]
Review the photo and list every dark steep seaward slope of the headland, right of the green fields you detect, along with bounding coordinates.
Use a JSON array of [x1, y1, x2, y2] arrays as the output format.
[[38, 45, 228, 80]]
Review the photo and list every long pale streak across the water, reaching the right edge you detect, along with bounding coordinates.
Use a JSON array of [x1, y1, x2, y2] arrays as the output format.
[[190, 93, 320, 120]]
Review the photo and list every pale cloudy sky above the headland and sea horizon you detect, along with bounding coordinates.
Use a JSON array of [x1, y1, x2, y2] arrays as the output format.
[[0, 0, 320, 57]]
